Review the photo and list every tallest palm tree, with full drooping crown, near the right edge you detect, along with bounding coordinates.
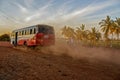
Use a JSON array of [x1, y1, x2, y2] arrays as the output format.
[[99, 16, 113, 40]]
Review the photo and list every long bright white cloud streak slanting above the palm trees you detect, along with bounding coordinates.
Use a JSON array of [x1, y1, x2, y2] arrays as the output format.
[[62, 1, 114, 20]]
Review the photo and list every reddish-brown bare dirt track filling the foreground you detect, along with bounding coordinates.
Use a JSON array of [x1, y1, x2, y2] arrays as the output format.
[[0, 41, 120, 80]]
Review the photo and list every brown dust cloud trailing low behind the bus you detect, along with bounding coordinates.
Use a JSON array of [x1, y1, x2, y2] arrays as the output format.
[[41, 40, 120, 64]]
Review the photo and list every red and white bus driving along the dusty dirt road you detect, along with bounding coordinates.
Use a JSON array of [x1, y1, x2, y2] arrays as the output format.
[[11, 24, 55, 46]]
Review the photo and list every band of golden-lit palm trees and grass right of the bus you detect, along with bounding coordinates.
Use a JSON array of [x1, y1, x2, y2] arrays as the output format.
[[62, 16, 120, 48]]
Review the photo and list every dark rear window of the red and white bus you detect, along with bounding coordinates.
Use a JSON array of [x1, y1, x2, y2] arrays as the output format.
[[38, 26, 54, 34]]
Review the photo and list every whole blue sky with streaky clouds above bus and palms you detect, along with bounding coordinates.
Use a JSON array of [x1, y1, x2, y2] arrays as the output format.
[[0, 0, 120, 34]]
